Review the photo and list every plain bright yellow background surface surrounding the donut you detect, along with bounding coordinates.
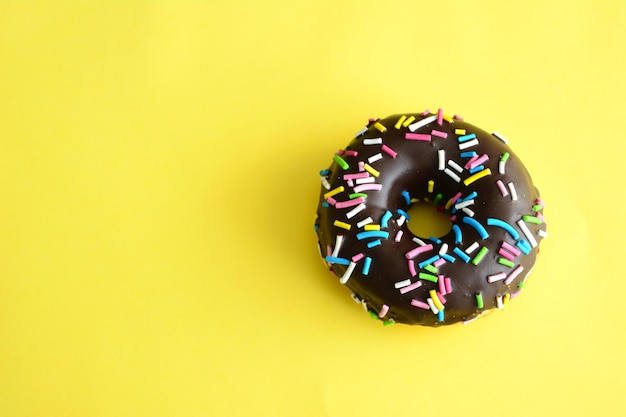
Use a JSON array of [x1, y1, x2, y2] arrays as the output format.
[[0, 0, 626, 417]]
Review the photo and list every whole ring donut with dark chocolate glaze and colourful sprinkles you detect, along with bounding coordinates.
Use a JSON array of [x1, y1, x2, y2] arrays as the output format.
[[315, 109, 547, 326]]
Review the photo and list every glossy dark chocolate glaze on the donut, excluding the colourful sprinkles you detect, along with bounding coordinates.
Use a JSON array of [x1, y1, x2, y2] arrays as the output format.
[[315, 113, 546, 326]]
